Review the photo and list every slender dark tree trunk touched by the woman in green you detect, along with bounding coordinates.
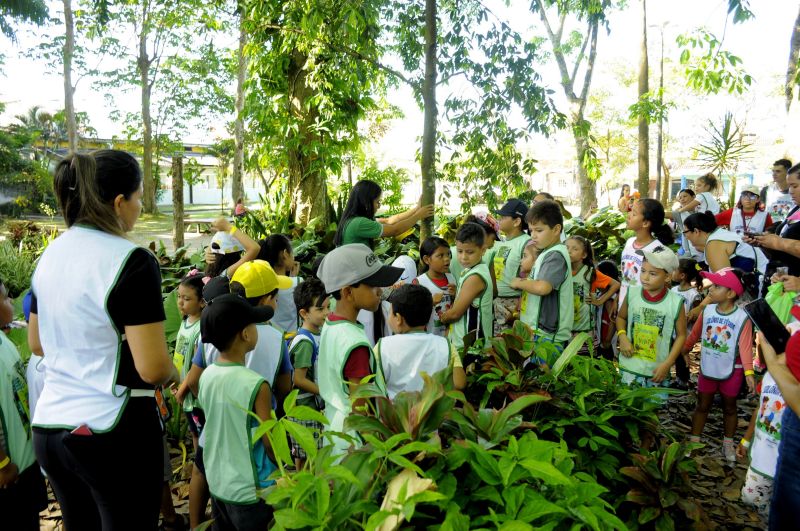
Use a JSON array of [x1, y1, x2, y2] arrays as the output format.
[[420, 0, 438, 240]]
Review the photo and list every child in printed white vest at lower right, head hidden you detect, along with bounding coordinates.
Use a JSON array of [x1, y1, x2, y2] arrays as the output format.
[[736, 372, 787, 518]]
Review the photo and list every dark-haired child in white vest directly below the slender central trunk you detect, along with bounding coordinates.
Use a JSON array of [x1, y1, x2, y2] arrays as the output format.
[[413, 236, 456, 337]]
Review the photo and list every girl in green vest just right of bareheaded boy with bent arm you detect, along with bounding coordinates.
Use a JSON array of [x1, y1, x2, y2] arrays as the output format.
[[566, 236, 619, 337]]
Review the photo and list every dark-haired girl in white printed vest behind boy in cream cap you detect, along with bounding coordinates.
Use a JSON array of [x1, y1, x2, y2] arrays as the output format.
[[619, 198, 674, 306]]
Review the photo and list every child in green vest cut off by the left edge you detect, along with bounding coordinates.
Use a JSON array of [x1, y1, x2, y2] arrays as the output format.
[[0, 281, 47, 531]]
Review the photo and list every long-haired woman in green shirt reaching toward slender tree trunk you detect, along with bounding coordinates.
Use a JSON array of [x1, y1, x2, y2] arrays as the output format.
[[333, 180, 433, 247]]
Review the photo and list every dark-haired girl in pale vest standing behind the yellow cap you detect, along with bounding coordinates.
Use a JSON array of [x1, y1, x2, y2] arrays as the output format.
[[258, 234, 303, 334]]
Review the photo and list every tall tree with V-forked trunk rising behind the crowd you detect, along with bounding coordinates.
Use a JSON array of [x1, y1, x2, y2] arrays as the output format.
[[532, 0, 603, 216]]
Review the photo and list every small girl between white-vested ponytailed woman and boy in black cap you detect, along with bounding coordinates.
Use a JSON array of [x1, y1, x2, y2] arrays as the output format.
[[172, 269, 206, 450]]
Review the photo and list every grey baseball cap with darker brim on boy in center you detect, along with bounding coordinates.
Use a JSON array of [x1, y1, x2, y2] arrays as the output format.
[[317, 243, 403, 293]]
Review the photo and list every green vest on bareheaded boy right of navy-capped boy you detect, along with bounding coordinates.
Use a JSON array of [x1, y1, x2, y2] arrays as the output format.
[[520, 243, 575, 343]]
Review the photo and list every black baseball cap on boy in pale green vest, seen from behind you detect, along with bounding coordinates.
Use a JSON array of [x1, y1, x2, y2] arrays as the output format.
[[200, 293, 275, 350]]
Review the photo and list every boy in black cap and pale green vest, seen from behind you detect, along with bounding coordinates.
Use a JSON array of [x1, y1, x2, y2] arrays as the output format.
[[197, 294, 275, 530]]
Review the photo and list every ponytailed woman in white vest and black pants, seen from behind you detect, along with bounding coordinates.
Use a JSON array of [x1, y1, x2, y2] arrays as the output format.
[[28, 150, 178, 529]]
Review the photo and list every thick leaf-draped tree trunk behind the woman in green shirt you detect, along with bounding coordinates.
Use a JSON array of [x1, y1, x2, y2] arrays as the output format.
[[288, 51, 330, 227]]
